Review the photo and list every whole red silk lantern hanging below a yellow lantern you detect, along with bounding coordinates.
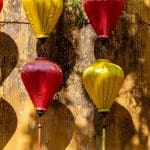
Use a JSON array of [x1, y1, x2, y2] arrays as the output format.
[[21, 57, 62, 115]]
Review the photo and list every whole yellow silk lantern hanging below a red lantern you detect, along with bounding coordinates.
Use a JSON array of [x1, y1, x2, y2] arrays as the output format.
[[82, 59, 124, 112]]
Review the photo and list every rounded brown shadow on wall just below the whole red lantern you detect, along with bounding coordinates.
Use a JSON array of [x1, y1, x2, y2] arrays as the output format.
[[25, 100, 75, 150]]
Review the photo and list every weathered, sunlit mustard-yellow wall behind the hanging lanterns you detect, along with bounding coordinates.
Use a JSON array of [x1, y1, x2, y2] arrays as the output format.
[[0, 0, 150, 150]]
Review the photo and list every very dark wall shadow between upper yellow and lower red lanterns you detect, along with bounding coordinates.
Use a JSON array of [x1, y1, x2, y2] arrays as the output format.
[[37, 16, 76, 85]]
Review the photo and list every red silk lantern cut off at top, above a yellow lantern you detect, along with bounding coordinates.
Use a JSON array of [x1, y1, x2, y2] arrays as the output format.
[[83, 0, 124, 39]]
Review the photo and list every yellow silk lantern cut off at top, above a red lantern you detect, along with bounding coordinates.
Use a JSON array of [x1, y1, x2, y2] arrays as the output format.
[[22, 0, 63, 38]]
